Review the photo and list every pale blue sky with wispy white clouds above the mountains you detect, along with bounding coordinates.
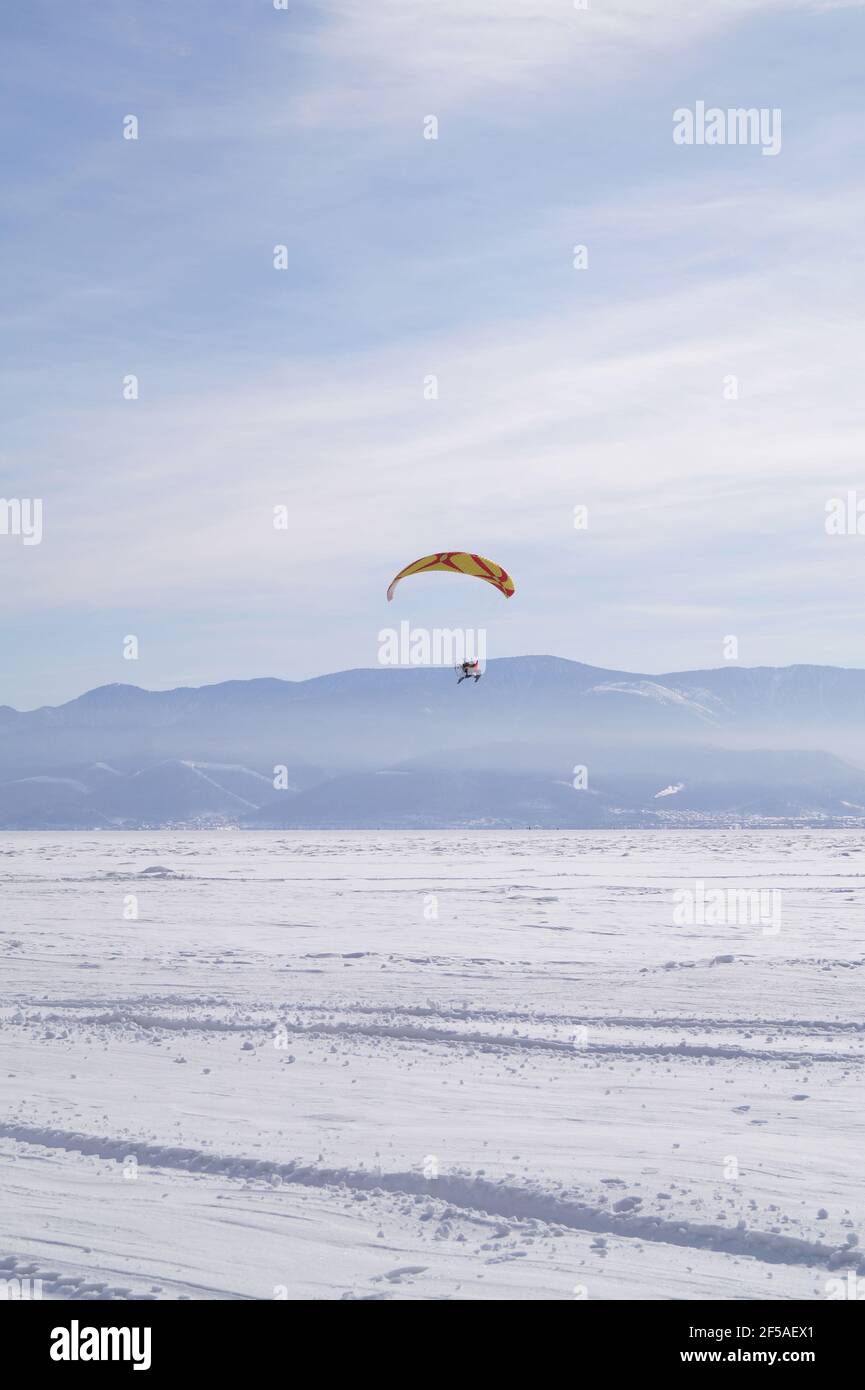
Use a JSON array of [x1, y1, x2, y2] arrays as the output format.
[[0, 0, 865, 709]]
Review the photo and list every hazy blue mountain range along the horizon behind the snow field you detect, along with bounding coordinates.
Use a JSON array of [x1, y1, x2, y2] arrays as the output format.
[[0, 656, 865, 830]]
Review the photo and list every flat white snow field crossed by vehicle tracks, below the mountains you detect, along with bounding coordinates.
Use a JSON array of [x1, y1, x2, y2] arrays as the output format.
[[0, 831, 865, 1300]]
